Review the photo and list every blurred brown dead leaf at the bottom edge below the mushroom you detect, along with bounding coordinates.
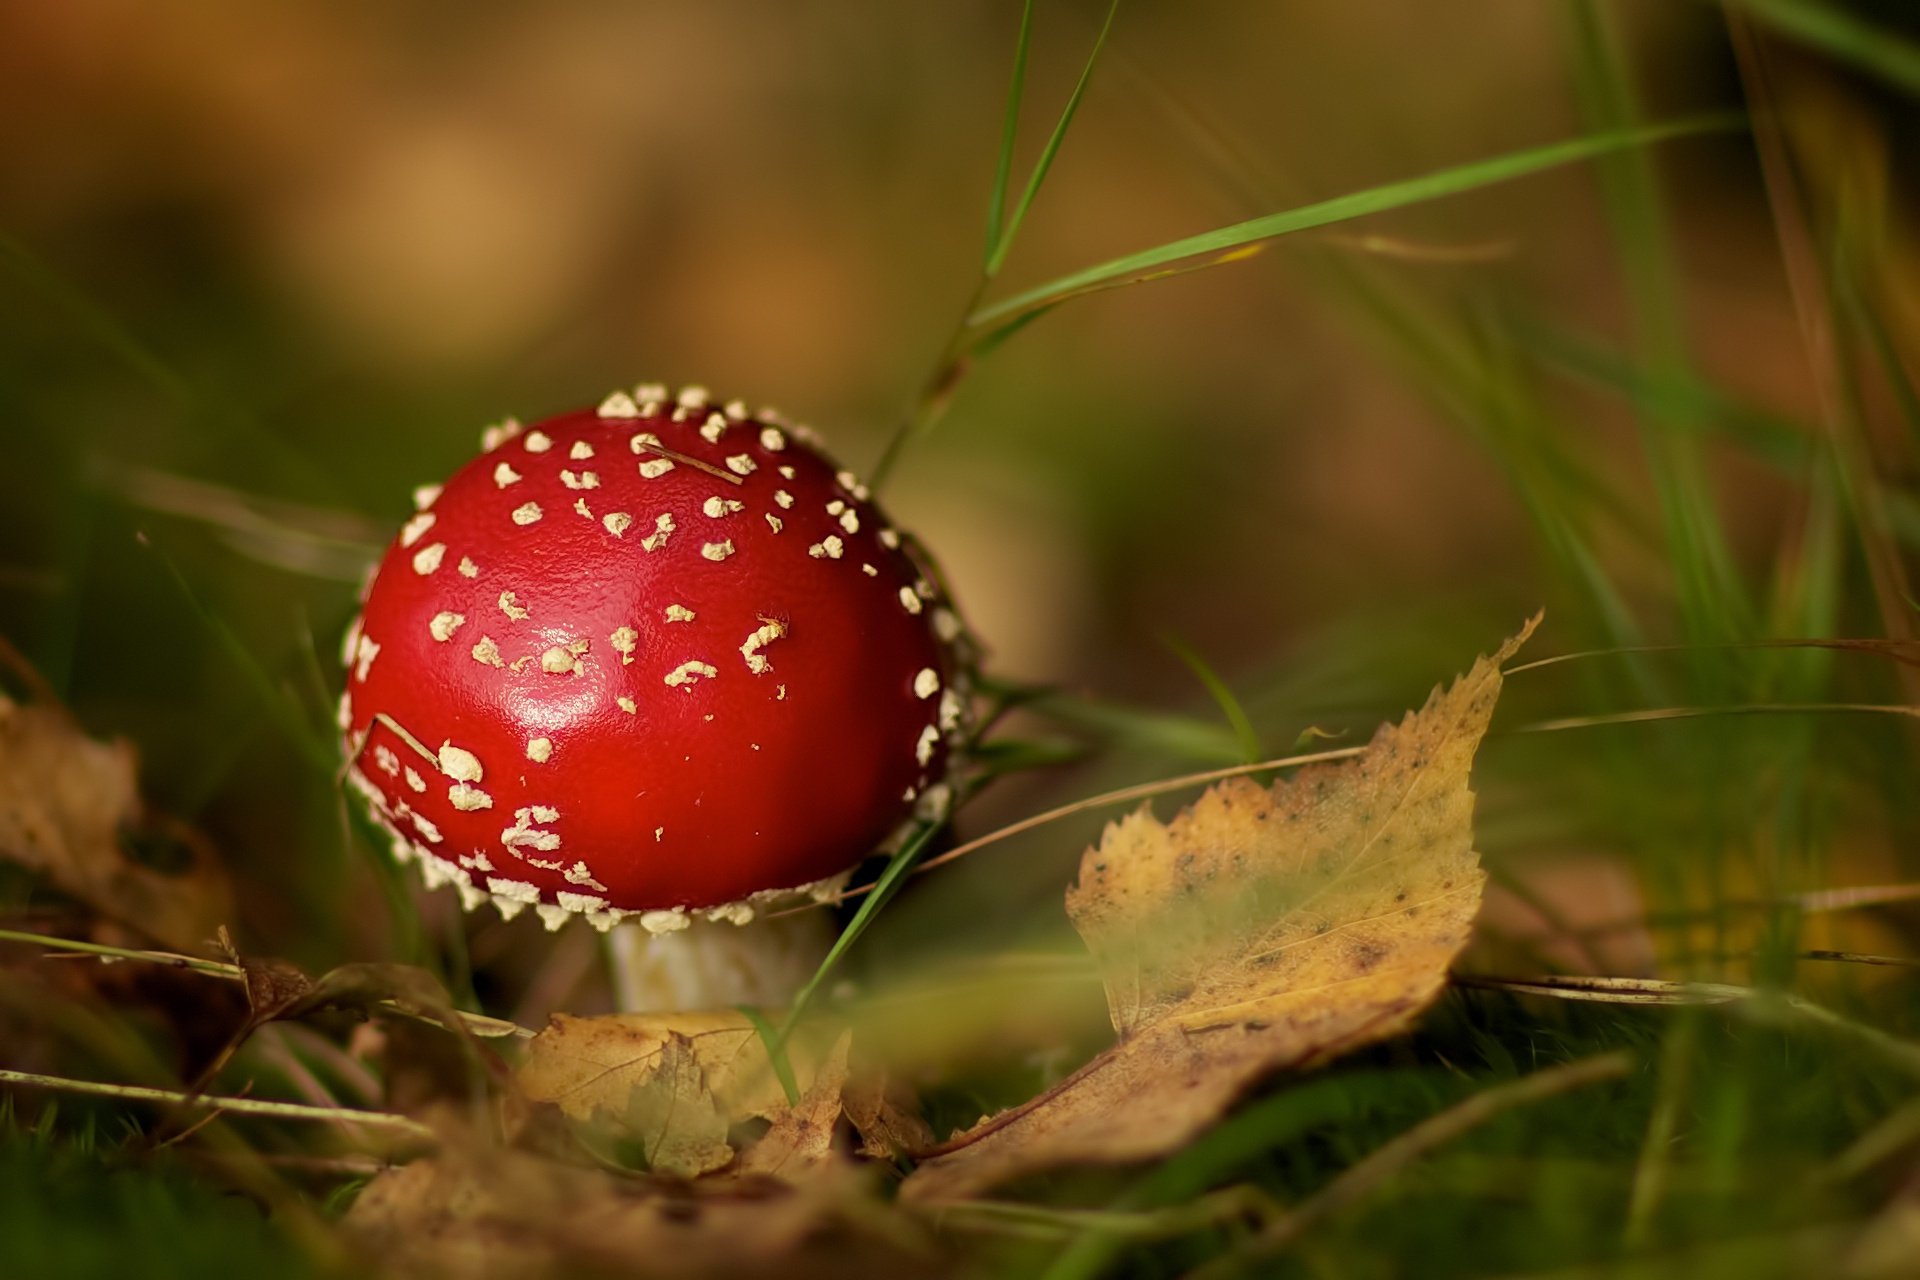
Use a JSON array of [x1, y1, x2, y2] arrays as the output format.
[[346, 1138, 945, 1280]]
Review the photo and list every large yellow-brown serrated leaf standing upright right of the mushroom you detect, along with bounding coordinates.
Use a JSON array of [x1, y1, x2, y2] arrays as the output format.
[[902, 618, 1538, 1201]]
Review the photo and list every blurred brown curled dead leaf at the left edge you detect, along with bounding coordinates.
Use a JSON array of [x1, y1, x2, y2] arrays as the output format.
[[0, 695, 232, 950]]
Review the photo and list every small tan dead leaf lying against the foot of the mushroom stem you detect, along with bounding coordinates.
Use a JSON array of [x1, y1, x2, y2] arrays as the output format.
[[518, 1009, 820, 1121]]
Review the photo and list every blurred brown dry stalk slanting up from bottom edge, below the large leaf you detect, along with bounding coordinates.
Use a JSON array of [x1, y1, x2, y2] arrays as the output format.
[[1187, 1052, 1634, 1280]]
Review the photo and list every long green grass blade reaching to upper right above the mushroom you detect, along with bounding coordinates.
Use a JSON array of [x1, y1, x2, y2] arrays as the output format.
[[970, 113, 1745, 326]]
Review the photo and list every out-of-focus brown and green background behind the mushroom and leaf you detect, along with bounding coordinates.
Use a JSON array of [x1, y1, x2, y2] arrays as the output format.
[[0, 0, 1920, 1017]]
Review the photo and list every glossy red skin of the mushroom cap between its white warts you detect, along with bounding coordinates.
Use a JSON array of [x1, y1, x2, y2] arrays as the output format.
[[348, 401, 954, 910]]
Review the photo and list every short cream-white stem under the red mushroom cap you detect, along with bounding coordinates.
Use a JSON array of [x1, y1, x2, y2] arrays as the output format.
[[607, 910, 833, 1013]]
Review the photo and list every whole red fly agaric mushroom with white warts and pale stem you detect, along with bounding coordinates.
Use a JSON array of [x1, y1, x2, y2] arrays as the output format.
[[340, 386, 966, 1006]]
